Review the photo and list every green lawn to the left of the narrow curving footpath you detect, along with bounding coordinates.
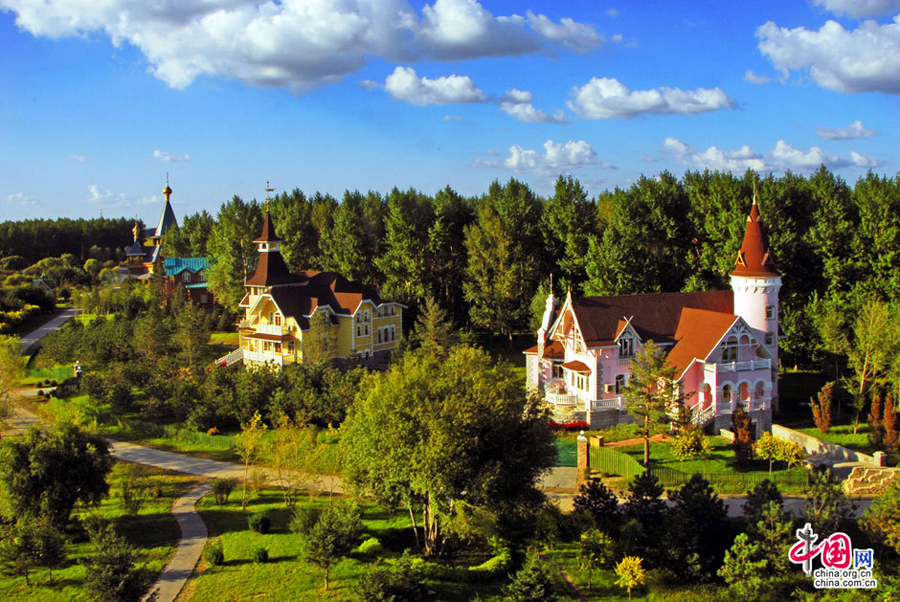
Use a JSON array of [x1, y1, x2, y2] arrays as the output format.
[[0, 462, 196, 602]]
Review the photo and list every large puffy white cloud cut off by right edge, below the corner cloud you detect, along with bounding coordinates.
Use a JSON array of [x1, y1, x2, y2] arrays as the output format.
[[756, 15, 900, 94]]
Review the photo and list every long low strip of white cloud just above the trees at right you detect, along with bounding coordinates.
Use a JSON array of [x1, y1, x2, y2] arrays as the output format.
[[663, 136, 883, 172]]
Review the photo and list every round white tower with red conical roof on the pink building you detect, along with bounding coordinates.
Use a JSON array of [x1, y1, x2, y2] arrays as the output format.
[[730, 194, 781, 409]]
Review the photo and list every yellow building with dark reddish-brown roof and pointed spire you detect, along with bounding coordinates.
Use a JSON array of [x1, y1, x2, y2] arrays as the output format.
[[239, 209, 404, 367]]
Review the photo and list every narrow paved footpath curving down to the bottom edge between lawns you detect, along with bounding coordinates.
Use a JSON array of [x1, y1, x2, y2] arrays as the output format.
[[144, 483, 210, 602]]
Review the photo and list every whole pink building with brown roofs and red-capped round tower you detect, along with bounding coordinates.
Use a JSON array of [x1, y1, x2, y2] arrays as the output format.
[[525, 198, 781, 434]]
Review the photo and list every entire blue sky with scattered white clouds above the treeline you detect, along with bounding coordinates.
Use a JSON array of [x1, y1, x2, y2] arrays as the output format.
[[0, 0, 900, 222]]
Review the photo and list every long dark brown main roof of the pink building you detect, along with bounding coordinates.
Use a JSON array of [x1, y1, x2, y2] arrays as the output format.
[[572, 291, 734, 347]]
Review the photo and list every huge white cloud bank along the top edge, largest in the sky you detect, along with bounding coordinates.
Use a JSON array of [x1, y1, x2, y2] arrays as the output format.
[[0, 0, 601, 94]]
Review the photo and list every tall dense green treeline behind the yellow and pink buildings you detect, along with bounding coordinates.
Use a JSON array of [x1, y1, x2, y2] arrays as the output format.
[[0, 167, 900, 364]]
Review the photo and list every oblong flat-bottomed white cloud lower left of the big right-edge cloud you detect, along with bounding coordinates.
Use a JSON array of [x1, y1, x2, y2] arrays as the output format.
[[566, 77, 735, 119]]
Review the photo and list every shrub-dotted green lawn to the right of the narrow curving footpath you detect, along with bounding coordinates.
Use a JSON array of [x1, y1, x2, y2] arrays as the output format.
[[186, 490, 506, 602]]
